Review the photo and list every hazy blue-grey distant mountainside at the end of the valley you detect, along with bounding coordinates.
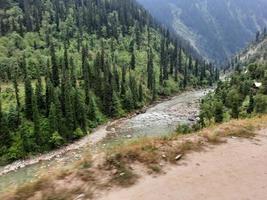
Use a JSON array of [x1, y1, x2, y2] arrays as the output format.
[[138, 0, 267, 61]]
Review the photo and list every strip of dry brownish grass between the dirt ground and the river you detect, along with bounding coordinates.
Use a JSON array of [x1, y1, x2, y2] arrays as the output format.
[[0, 116, 267, 200]]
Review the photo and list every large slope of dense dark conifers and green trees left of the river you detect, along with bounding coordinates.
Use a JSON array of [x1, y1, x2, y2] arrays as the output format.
[[0, 0, 219, 164]]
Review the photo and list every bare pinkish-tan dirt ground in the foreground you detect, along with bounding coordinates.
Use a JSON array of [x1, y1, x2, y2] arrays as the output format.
[[97, 129, 267, 200]]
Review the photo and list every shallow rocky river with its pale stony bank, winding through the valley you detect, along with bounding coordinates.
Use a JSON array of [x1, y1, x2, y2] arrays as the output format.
[[0, 90, 210, 192]]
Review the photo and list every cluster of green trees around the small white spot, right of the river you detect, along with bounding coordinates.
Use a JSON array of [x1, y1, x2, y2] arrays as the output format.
[[200, 63, 267, 126]]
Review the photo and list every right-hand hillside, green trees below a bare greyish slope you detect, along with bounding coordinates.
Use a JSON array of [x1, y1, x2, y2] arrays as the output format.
[[200, 28, 267, 126]]
